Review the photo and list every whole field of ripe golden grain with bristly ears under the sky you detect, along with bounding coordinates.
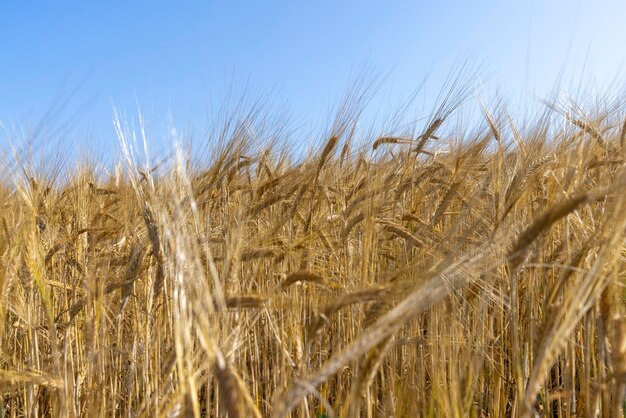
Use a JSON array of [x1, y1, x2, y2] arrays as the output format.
[[0, 83, 626, 417]]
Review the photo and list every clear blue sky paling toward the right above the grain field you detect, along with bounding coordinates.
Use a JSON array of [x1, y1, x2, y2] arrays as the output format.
[[0, 0, 626, 162]]
